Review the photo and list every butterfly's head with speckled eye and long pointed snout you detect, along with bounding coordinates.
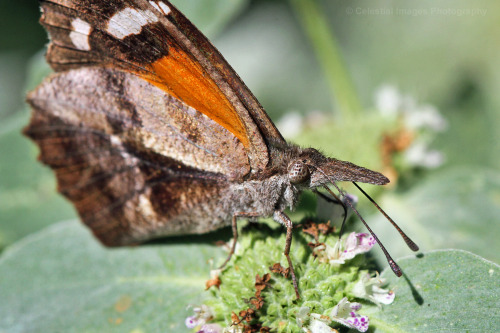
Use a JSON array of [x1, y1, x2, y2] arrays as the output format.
[[287, 148, 389, 188]]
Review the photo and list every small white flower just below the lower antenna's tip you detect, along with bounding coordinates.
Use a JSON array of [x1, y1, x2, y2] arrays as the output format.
[[352, 273, 396, 306]]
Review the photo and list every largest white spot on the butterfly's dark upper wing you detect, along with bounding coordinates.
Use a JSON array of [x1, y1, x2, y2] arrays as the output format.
[[107, 8, 158, 39]]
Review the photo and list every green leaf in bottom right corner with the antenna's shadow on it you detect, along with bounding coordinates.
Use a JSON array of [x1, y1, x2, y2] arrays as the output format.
[[364, 250, 500, 332]]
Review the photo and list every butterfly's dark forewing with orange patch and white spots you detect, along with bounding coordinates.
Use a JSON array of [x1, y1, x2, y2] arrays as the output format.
[[41, 0, 284, 171]]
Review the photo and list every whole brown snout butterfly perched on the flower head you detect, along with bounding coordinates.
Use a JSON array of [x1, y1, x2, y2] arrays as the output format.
[[24, 0, 418, 297]]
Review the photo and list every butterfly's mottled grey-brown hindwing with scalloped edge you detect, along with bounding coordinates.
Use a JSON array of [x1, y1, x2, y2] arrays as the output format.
[[25, 68, 243, 245]]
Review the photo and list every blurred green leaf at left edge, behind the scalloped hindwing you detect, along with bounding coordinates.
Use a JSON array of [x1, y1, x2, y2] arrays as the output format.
[[0, 113, 75, 249]]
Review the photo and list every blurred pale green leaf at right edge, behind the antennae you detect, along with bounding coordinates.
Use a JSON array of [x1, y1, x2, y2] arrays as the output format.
[[368, 167, 500, 262]]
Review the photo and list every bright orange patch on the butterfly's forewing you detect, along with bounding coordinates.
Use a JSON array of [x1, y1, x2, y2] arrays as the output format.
[[141, 47, 250, 147]]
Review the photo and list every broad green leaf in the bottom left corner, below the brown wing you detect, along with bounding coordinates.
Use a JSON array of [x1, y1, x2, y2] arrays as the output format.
[[0, 221, 225, 332]]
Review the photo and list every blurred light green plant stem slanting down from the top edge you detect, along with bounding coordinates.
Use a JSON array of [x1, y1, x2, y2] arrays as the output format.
[[289, 0, 361, 119]]
